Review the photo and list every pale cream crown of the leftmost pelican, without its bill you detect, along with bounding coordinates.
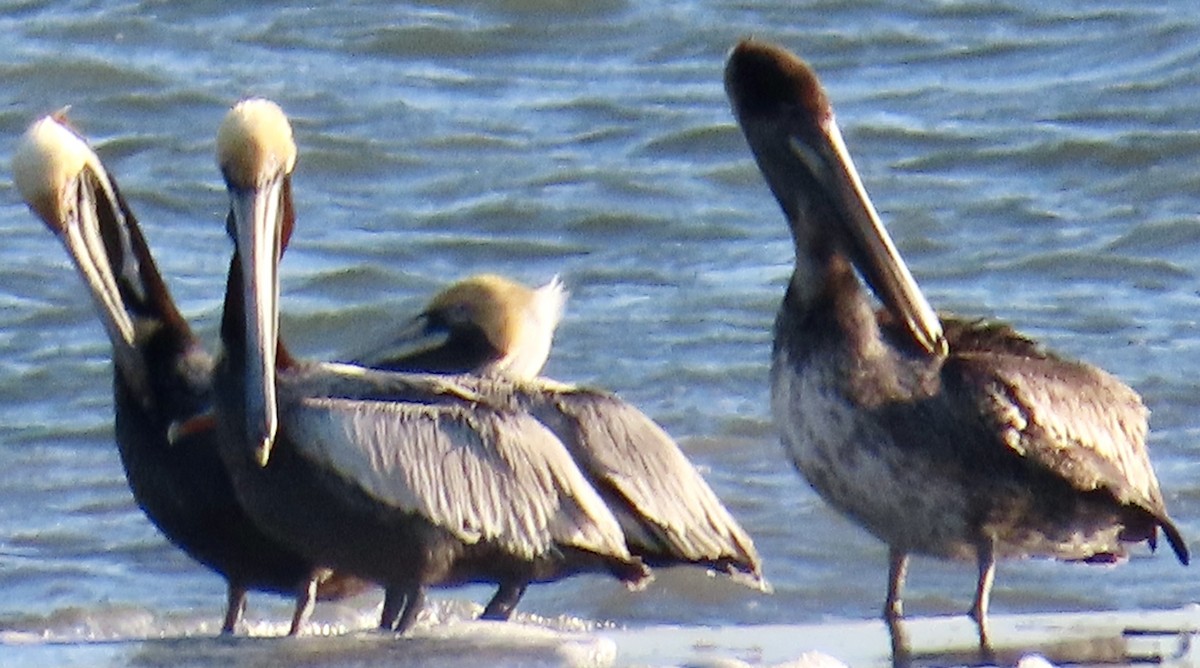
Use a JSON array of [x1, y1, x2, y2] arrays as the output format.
[[12, 111, 104, 223]]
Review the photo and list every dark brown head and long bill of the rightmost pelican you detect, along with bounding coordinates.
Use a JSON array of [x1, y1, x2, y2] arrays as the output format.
[[725, 40, 946, 354]]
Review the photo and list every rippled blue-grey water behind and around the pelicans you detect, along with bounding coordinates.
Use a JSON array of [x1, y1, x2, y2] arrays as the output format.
[[0, 0, 1200, 657]]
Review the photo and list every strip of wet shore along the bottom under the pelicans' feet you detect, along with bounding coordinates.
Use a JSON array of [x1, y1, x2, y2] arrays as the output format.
[[0, 607, 1200, 668]]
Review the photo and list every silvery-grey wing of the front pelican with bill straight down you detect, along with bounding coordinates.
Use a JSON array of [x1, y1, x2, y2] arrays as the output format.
[[281, 374, 630, 559]]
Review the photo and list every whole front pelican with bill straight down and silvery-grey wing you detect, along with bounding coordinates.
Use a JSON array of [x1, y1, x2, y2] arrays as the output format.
[[214, 100, 648, 631]]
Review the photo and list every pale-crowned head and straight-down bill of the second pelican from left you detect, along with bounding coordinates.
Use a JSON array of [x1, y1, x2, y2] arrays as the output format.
[[217, 98, 296, 467]]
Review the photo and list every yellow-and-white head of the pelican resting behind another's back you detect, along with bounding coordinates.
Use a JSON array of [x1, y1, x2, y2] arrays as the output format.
[[373, 273, 566, 378]]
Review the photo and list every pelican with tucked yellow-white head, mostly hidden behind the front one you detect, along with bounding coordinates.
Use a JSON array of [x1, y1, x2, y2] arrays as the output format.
[[364, 275, 769, 619]]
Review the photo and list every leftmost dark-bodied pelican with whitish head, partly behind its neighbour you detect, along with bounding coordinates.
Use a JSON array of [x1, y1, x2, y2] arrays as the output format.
[[13, 116, 366, 634]]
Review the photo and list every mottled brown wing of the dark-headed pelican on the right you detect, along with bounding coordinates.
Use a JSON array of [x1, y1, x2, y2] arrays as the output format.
[[943, 323, 1165, 517]]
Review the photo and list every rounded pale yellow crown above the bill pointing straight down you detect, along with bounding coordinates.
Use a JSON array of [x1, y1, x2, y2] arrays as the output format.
[[217, 97, 296, 188]]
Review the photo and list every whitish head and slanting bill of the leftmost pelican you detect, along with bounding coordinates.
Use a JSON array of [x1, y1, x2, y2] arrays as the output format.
[[12, 115, 144, 384]]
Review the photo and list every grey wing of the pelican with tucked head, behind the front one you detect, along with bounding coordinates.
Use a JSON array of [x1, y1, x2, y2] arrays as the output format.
[[499, 380, 767, 589]]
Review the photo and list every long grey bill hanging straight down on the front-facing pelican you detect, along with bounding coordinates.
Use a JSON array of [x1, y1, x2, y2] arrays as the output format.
[[230, 179, 287, 467]]
